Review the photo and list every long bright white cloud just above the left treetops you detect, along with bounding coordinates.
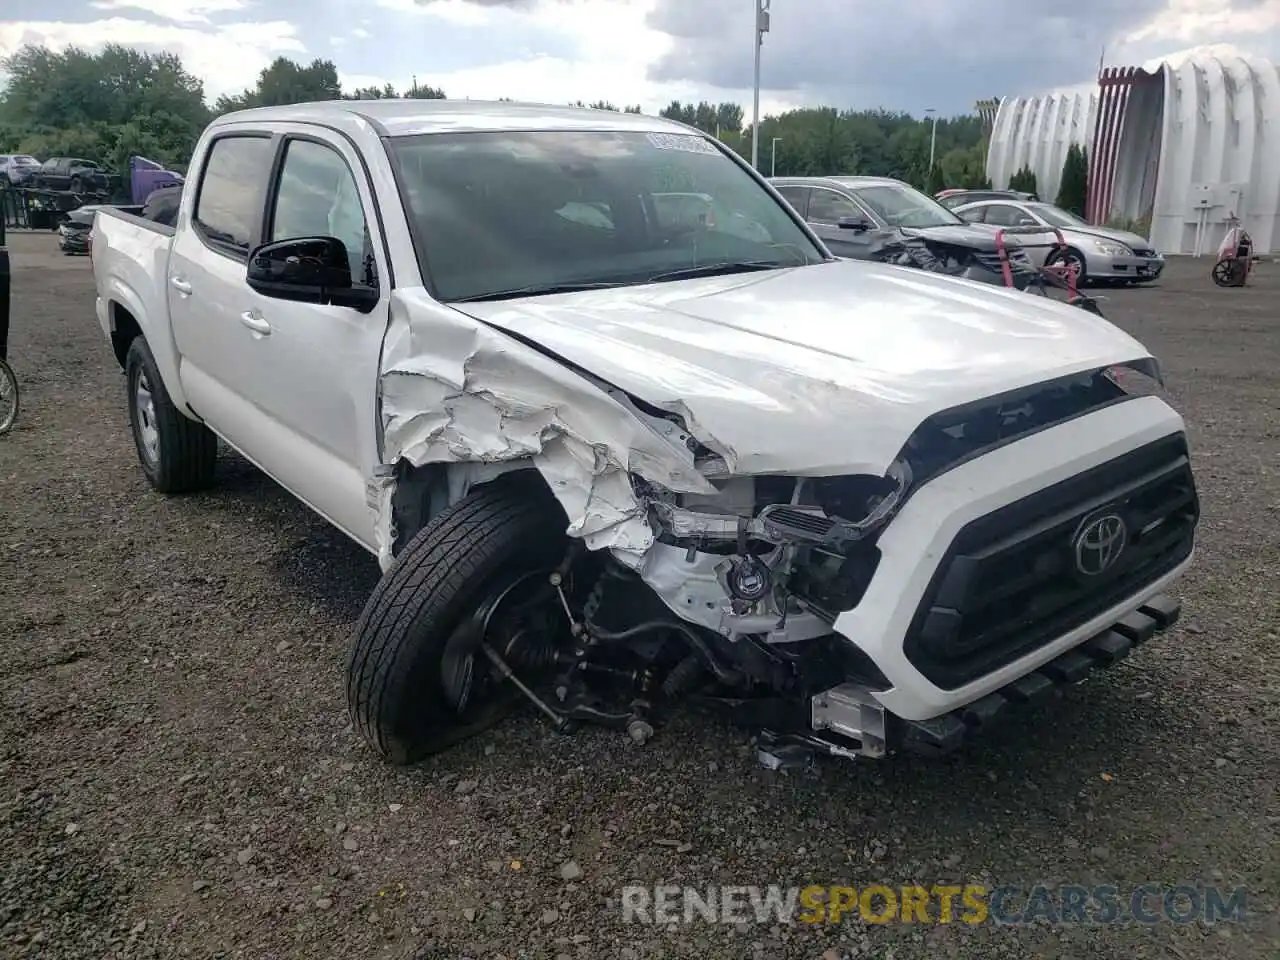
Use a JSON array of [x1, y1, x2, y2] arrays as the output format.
[[0, 17, 306, 100]]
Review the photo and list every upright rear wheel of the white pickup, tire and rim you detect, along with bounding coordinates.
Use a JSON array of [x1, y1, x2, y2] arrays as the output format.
[[124, 337, 218, 494]]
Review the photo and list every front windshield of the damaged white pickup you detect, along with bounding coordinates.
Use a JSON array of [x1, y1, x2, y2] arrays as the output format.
[[388, 131, 824, 301]]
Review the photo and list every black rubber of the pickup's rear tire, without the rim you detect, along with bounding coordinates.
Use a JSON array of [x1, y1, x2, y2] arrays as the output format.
[[124, 337, 218, 494]]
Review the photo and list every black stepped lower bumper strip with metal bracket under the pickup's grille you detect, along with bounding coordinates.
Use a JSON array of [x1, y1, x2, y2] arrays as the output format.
[[759, 594, 1181, 767]]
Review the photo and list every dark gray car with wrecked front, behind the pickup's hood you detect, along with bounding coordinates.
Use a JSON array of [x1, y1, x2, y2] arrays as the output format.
[[771, 177, 1034, 289]]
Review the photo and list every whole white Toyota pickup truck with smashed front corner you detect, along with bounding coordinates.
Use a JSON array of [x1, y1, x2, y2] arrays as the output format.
[[92, 100, 1199, 763]]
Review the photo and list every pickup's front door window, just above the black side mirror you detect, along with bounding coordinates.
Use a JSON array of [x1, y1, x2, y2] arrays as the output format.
[[270, 140, 378, 287]]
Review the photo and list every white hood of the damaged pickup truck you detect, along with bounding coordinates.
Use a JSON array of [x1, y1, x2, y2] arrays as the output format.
[[454, 261, 1148, 476]]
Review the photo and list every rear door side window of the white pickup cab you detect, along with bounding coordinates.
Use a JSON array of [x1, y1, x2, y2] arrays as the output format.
[[191, 137, 271, 255]]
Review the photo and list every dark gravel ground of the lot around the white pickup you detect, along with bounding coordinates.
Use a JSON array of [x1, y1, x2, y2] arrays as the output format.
[[0, 236, 1280, 960]]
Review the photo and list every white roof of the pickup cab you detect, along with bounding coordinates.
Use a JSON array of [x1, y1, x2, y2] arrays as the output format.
[[214, 100, 698, 137]]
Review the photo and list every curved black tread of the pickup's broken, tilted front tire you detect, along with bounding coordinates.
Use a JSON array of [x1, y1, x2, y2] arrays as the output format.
[[347, 477, 564, 765]]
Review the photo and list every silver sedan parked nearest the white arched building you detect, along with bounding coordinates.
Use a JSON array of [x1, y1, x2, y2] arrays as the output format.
[[955, 200, 1165, 284]]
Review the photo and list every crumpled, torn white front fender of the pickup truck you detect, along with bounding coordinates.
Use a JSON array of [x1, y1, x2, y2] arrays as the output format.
[[378, 291, 716, 570]]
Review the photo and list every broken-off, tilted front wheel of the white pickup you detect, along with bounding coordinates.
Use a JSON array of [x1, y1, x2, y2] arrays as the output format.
[[347, 476, 567, 765]]
